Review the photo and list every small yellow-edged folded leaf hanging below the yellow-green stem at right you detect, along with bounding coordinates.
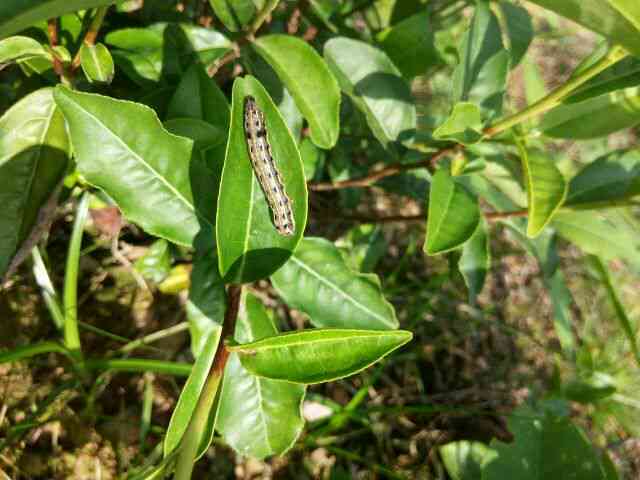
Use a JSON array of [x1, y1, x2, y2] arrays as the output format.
[[520, 147, 567, 238]]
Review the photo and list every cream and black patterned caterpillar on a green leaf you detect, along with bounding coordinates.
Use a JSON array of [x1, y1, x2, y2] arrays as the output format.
[[244, 95, 295, 236]]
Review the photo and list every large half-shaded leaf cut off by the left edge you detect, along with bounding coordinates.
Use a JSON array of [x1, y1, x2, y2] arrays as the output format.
[[0, 88, 69, 276]]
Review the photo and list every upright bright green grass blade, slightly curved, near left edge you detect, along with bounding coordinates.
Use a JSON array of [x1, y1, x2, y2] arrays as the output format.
[[64, 192, 89, 363]]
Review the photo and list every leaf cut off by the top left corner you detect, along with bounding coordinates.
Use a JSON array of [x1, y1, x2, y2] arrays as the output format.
[[0, 0, 115, 38]]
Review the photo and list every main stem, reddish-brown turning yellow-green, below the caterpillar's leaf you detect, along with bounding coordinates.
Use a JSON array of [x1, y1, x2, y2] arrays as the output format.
[[174, 285, 242, 480]]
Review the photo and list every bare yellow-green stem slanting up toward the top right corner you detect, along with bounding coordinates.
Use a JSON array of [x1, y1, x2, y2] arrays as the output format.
[[484, 45, 629, 138]]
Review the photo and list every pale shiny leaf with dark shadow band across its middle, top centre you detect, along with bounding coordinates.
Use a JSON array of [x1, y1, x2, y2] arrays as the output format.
[[324, 37, 416, 148]]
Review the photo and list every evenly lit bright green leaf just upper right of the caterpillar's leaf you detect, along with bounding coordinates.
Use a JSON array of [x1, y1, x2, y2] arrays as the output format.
[[254, 35, 340, 149]]
